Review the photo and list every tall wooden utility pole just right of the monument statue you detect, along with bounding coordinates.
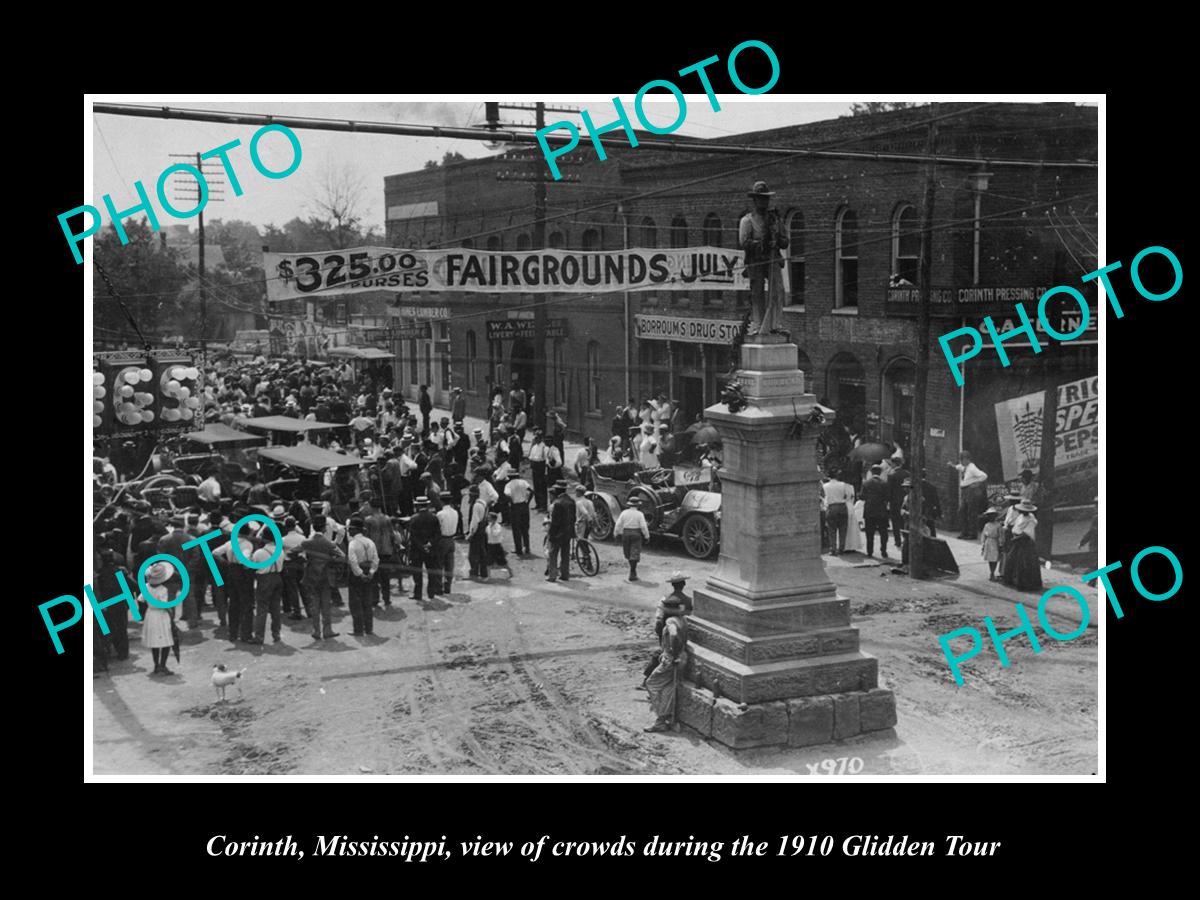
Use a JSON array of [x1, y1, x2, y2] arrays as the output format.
[[908, 109, 936, 578]]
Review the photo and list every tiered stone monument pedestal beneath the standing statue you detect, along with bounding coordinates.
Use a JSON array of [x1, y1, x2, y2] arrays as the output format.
[[678, 335, 896, 748]]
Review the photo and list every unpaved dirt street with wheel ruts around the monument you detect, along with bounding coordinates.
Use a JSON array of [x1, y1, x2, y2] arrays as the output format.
[[92, 523, 1098, 775]]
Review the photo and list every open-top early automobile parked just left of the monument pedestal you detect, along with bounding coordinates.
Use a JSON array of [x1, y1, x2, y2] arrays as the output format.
[[587, 462, 721, 559]]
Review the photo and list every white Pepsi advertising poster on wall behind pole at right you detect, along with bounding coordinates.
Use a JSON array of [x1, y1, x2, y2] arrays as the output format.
[[996, 376, 1100, 485]]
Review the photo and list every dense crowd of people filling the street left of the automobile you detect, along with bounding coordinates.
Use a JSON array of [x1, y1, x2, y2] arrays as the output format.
[[94, 358, 613, 674]]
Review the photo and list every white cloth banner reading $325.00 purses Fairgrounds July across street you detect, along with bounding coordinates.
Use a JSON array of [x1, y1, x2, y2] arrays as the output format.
[[263, 247, 750, 302]]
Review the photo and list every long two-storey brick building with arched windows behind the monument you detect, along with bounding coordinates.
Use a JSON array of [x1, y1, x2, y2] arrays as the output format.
[[384, 103, 1097, 500]]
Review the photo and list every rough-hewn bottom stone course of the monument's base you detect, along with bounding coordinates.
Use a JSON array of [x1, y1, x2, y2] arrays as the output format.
[[678, 680, 896, 750]]
